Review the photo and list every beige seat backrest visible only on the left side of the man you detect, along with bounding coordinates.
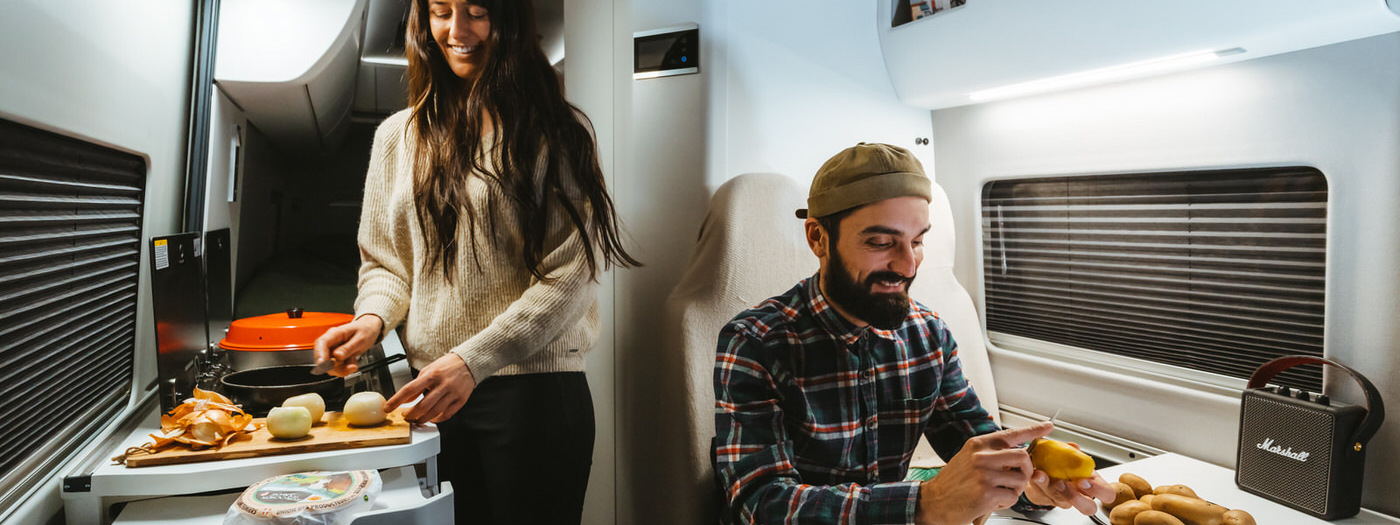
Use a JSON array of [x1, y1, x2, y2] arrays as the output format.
[[660, 174, 818, 525]]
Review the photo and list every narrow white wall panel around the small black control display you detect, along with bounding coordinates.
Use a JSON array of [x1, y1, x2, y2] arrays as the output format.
[[627, 0, 718, 524]]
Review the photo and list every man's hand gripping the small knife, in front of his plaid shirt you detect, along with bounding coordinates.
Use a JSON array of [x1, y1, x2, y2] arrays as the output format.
[[914, 423, 1054, 525]]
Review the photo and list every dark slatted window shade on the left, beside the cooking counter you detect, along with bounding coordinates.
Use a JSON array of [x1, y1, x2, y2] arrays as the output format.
[[0, 120, 146, 508]]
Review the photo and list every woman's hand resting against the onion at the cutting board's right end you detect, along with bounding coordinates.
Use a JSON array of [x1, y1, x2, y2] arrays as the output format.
[[384, 353, 476, 423]]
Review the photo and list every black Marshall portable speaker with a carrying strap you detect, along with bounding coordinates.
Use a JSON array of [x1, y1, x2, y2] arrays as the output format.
[[1235, 356, 1386, 519]]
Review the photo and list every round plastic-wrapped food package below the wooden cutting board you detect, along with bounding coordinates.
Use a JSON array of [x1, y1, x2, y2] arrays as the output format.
[[224, 470, 382, 525]]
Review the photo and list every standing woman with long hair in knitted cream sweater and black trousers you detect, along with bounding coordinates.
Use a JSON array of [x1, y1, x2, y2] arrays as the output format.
[[316, 0, 637, 524]]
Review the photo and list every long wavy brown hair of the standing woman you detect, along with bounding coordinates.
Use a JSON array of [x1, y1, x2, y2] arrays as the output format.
[[406, 0, 641, 280]]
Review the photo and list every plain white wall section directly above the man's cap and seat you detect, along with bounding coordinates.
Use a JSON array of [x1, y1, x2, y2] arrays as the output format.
[[700, 0, 932, 192]]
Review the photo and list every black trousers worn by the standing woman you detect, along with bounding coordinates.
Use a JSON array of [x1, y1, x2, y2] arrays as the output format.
[[438, 372, 594, 525]]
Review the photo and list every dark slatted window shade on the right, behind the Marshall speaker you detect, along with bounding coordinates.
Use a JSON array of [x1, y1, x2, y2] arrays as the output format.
[[981, 168, 1327, 392]]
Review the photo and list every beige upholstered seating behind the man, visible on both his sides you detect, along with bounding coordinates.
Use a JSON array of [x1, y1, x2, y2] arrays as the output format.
[[645, 174, 1000, 524]]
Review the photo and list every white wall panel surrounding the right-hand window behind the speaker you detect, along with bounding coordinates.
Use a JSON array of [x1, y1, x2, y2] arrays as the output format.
[[932, 34, 1400, 514]]
